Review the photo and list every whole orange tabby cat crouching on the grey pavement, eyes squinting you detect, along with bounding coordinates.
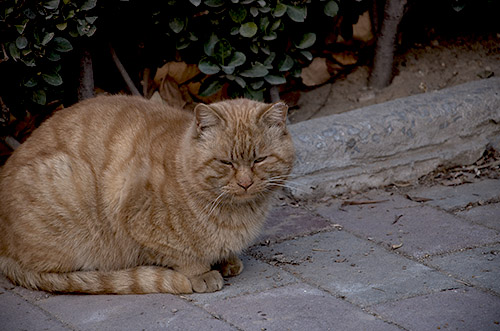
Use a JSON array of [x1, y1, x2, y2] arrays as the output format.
[[0, 96, 294, 293]]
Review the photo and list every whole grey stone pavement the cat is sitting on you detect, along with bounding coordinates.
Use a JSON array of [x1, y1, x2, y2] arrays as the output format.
[[0, 178, 500, 330]]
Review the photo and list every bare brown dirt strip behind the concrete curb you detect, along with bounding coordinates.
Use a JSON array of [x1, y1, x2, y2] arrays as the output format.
[[290, 33, 500, 123]]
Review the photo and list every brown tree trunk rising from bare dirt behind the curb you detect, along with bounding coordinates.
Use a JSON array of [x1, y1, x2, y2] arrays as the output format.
[[370, 0, 407, 89]]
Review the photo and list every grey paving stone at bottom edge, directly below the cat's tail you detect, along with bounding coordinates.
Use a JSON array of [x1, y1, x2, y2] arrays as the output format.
[[38, 294, 234, 330]]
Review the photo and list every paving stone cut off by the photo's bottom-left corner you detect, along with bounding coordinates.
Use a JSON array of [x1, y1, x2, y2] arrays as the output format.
[[0, 290, 71, 331]]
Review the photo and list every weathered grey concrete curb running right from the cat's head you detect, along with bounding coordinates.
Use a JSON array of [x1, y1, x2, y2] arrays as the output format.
[[290, 78, 500, 197]]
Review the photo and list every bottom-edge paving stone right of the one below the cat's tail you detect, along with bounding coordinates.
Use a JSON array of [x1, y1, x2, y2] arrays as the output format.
[[203, 284, 399, 331]]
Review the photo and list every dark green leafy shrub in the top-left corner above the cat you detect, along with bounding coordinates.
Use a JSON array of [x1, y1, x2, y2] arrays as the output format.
[[0, 0, 97, 109]]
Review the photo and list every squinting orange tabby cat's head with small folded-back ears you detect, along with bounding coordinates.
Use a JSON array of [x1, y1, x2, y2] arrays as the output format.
[[183, 99, 295, 203]]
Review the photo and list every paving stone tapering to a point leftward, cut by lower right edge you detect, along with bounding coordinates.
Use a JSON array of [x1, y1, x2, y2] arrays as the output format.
[[426, 245, 500, 294]]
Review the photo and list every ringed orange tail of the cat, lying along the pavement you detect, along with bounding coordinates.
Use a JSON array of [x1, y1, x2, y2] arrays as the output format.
[[0, 256, 192, 294]]
